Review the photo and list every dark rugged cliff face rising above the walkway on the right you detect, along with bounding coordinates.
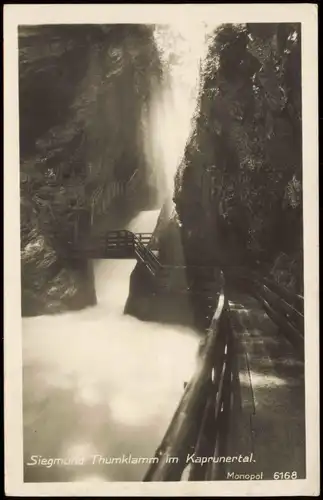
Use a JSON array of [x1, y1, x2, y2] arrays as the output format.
[[165, 23, 303, 292]]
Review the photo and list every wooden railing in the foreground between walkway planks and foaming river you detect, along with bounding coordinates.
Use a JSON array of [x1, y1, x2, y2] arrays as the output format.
[[144, 280, 232, 481]]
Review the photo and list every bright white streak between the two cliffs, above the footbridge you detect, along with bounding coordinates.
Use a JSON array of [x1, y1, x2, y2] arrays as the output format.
[[142, 22, 213, 205]]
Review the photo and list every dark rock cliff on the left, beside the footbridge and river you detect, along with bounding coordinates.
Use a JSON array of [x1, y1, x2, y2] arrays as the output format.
[[19, 25, 161, 315]]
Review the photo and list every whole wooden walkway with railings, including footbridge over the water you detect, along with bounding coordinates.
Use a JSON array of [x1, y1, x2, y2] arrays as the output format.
[[71, 230, 305, 481]]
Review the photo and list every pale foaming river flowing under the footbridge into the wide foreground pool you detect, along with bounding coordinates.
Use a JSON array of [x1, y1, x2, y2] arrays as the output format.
[[23, 211, 199, 482]]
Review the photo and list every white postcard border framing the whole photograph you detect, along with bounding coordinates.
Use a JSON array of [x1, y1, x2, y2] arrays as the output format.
[[4, 4, 319, 497]]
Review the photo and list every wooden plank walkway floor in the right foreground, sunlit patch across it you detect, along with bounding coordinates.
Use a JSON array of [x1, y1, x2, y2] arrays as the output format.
[[225, 295, 305, 480]]
